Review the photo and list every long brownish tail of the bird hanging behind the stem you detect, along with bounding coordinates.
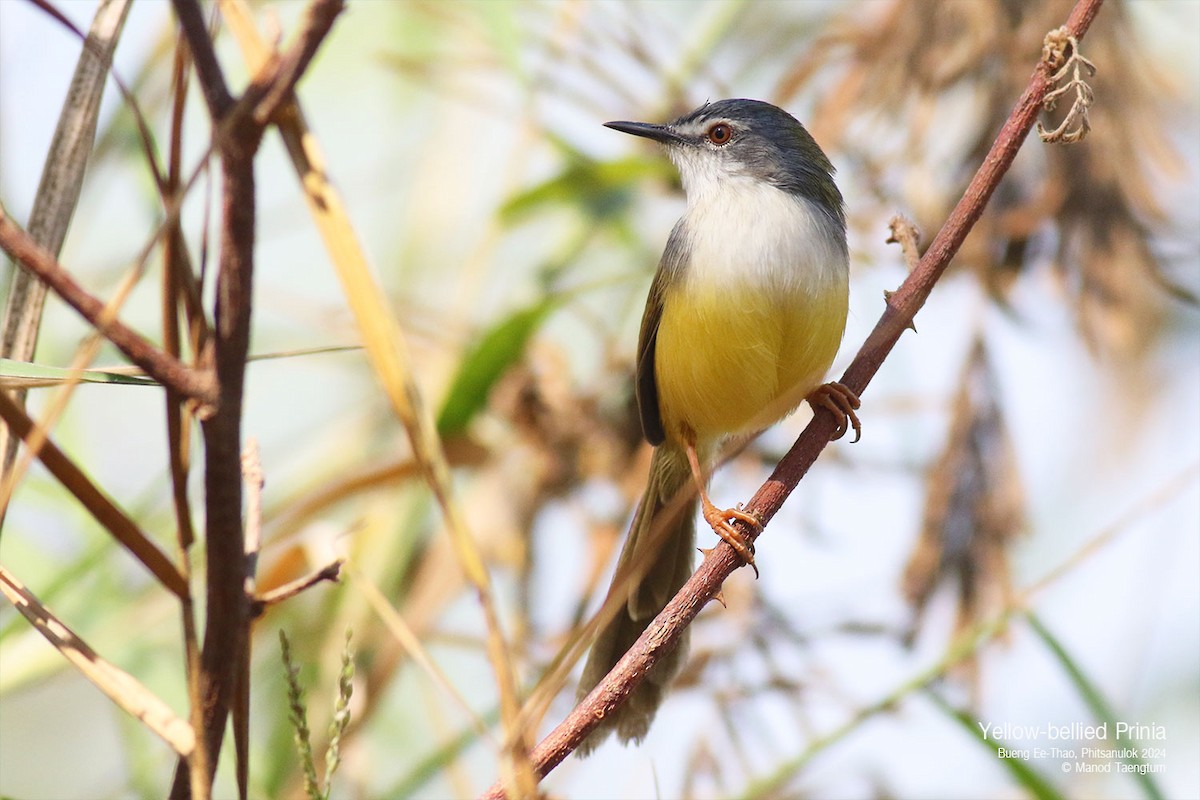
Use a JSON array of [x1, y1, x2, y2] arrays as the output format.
[[578, 445, 696, 754]]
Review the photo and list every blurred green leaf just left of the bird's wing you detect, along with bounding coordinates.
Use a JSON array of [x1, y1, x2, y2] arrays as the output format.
[[438, 297, 557, 438]]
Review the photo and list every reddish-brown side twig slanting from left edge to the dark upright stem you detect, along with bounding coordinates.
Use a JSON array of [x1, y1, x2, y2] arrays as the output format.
[[0, 207, 216, 404]]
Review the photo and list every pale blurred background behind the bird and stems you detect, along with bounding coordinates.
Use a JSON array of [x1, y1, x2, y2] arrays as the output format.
[[0, 0, 1200, 799]]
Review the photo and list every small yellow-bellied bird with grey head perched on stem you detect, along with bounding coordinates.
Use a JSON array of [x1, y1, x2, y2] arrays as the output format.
[[578, 98, 860, 754]]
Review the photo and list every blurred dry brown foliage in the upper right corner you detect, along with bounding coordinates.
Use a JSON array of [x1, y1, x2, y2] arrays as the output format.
[[780, 0, 1196, 359]]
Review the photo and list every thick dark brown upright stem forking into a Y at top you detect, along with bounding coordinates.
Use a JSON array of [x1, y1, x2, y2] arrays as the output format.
[[163, 0, 342, 798]]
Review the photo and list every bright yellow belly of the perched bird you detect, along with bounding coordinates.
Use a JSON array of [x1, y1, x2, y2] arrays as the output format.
[[654, 281, 847, 443]]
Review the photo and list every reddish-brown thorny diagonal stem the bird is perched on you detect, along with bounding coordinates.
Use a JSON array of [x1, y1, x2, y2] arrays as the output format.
[[482, 0, 1102, 800]]
